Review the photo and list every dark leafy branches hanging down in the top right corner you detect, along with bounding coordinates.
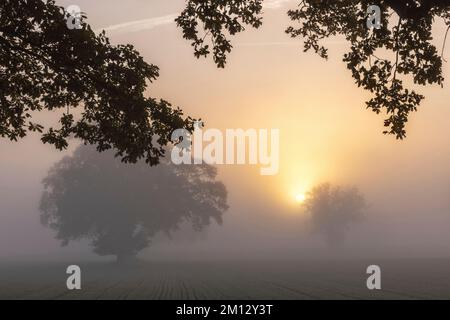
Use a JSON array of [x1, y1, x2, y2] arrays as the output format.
[[286, 0, 450, 139]]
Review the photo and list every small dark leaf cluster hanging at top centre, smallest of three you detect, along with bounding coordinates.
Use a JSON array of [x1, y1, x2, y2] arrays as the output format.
[[175, 0, 262, 68]]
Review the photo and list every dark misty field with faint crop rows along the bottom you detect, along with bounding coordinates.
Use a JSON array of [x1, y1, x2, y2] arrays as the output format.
[[0, 259, 450, 300]]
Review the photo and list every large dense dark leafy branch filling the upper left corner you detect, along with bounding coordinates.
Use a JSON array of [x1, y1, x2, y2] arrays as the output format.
[[0, 0, 194, 165]]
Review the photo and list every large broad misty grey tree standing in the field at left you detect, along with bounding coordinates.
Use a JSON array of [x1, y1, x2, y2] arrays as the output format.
[[40, 146, 228, 261]]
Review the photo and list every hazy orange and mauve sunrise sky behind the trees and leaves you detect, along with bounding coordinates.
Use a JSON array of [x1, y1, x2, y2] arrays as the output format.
[[0, 0, 450, 259]]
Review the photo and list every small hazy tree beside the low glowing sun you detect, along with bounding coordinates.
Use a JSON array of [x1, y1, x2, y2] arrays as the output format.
[[303, 183, 365, 246]]
